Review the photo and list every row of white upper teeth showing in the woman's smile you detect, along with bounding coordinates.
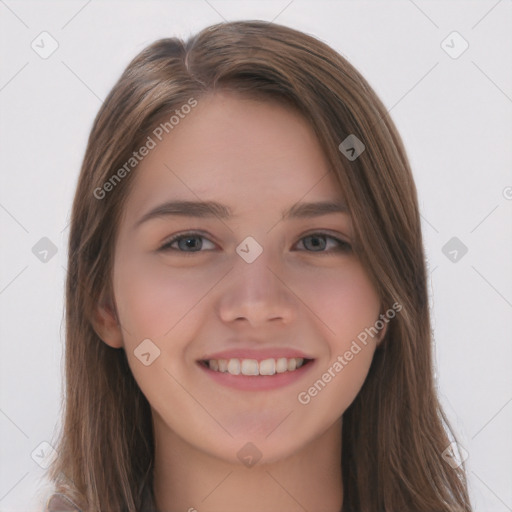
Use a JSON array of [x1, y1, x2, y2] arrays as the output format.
[[207, 357, 304, 375]]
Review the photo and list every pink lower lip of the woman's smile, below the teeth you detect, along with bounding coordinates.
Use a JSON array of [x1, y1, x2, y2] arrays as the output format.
[[198, 360, 315, 391]]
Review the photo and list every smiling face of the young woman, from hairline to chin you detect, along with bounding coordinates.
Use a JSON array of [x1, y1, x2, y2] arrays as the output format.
[[96, 93, 380, 462]]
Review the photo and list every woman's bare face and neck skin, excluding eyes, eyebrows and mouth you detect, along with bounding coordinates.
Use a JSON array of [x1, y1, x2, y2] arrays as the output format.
[[95, 92, 385, 512]]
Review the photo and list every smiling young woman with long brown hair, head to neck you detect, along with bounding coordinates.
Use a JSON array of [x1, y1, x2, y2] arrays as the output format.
[[47, 21, 471, 512]]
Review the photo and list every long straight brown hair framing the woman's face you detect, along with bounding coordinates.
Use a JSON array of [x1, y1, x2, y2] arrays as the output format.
[[49, 21, 471, 512]]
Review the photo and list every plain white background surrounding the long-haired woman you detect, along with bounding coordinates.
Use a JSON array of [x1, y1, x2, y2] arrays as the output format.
[[0, 0, 512, 512]]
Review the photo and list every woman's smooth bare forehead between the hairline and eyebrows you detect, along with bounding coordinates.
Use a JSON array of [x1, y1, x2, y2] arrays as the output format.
[[129, 92, 342, 210]]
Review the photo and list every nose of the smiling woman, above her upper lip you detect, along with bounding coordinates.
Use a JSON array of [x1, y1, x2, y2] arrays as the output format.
[[219, 250, 297, 327]]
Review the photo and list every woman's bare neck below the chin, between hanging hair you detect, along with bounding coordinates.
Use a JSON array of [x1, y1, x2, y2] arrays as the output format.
[[153, 411, 343, 512]]
